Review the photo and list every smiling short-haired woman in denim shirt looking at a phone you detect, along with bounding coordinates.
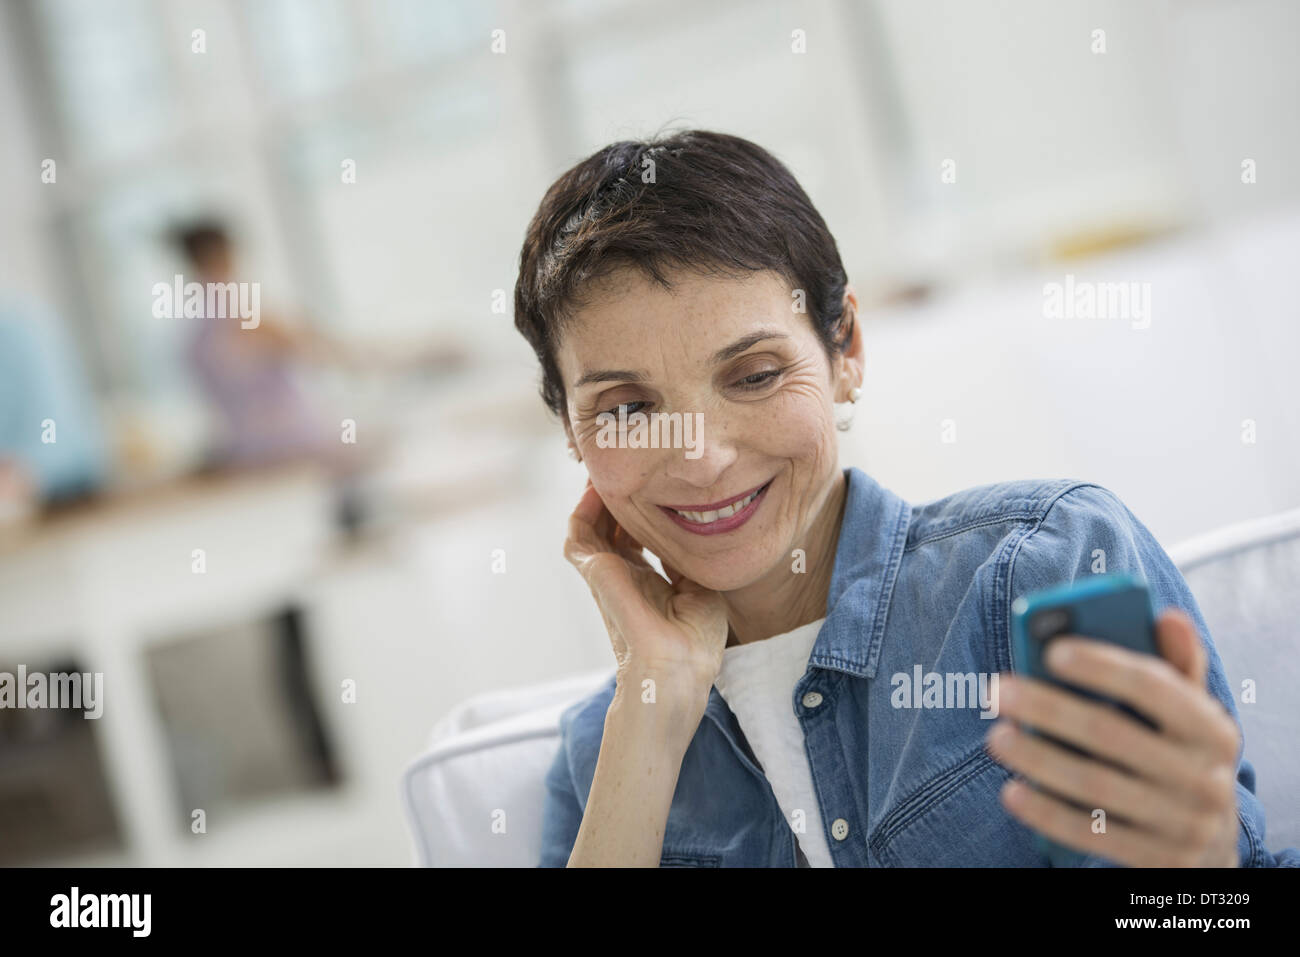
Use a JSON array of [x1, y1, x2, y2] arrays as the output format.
[[515, 131, 1292, 867]]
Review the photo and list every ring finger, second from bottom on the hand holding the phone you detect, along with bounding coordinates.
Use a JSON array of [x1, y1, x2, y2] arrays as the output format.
[[988, 722, 1209, 841]]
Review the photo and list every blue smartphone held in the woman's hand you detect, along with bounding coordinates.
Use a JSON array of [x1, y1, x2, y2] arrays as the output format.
[[1011, 575, 1160, 867]]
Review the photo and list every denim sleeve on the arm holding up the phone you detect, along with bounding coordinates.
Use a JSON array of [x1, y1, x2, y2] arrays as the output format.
[[1009, 484, 1300, 867]]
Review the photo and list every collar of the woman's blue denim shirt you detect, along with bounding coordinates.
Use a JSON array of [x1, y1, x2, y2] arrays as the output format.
[[706, 465, 911, 729]]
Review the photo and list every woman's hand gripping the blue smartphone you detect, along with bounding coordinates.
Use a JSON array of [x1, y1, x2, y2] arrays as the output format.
[[988, 609, 1242, 867]]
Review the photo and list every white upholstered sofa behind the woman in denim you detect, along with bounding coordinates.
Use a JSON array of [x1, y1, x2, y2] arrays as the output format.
[[403, 508, 1300, 867]]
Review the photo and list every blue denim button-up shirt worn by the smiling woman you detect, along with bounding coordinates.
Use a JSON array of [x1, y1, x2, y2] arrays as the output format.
[[541, 468, 1300, 867]]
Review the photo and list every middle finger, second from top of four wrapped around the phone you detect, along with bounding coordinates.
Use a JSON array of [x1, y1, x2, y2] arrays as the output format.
[[996, 675, 1218, 805]]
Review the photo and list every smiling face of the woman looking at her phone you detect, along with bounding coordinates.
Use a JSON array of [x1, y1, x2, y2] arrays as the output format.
[[556, 263, 861, 592]]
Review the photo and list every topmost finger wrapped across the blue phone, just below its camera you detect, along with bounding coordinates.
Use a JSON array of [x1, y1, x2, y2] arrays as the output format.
[[1045, 636, 1235, 753]]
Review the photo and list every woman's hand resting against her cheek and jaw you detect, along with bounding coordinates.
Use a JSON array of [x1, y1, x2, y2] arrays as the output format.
[[564, 479, 728, 707]]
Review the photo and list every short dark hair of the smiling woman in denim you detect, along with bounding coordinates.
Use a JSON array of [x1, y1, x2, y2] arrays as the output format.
[[515, 130, 853, 417]]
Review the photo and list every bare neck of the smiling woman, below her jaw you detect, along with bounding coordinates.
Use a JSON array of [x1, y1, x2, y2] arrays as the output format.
[[723, 469, 849, 648]]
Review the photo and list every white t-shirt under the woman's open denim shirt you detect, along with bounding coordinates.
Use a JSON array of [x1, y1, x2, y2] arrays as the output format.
[[714, 618, 835, 867]]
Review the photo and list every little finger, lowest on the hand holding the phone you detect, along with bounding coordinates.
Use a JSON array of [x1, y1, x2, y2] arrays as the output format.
[[1000, 781, 1195, 867]]
